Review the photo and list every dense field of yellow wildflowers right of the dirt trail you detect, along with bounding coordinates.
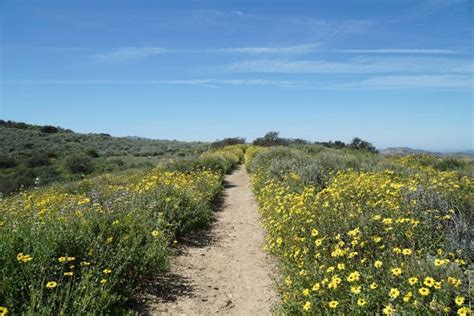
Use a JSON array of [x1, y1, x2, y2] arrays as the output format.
[[246, 146, 474, 315]]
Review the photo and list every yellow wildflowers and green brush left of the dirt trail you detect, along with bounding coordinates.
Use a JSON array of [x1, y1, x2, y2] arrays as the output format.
[[0, 146, 244, 315]]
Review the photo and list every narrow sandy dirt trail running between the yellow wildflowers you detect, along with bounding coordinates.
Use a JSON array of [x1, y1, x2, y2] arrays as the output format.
[[144, 167, 277, 315]]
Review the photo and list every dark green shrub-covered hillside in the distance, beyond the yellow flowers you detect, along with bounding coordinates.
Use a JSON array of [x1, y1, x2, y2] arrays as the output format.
[[0, 120, 208, 195]]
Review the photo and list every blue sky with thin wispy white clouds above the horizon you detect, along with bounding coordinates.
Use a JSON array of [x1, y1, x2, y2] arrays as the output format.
[[0, 0, 474, 150]]
